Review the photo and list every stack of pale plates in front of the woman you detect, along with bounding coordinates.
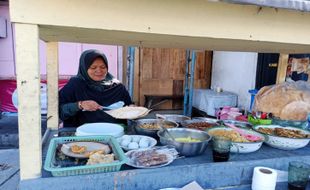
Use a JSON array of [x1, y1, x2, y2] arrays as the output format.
[[75, 123, 124, 138]]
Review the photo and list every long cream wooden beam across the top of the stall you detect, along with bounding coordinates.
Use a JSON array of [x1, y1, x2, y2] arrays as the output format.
[[10, 0, 310, 53]]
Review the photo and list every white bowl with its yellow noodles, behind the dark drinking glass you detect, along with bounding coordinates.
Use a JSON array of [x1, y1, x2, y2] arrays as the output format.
[[207, 126, 265, 153]]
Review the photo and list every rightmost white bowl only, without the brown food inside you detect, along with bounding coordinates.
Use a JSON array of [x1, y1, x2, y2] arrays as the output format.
[[253, 125, 310, 150]]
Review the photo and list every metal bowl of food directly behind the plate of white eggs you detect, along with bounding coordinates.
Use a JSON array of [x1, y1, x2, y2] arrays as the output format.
[[134, 119, 179, 138]]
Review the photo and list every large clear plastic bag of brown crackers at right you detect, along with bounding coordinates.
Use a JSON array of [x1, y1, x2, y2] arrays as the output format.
[[254, 81, 310, 121]]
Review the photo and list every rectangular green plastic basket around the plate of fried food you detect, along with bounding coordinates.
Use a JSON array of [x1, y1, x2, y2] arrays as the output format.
[[44, 136, 128, 176]]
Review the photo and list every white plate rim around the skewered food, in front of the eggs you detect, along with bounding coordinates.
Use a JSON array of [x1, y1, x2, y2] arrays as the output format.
[[125, 148, 174, 168]]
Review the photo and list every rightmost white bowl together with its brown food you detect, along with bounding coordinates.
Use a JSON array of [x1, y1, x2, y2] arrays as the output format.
[[253, 125, 310, 150]]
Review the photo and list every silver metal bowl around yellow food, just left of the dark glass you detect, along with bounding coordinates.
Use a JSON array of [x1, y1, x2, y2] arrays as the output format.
[[157, 128, 211, 156]]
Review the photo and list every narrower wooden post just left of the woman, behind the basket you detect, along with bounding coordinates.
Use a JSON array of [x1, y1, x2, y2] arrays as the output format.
[[46, 42, 59, 130]]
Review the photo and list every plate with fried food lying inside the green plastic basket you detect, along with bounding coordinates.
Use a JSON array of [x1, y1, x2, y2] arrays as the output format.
[[61, 141, 111, 158]]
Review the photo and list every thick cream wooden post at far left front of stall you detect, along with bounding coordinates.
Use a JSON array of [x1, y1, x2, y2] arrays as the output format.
[[15, 23, 42, 180]]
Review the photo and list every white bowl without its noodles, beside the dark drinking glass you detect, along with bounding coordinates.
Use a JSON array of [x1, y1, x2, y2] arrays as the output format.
[[207, 127, 265, 153]]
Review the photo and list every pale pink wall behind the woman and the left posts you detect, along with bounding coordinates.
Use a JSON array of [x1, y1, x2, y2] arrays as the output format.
[[0, 5, 117, 79]]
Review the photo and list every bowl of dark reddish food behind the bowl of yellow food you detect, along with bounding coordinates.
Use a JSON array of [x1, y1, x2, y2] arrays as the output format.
[[181, 117, 220, 131]]
